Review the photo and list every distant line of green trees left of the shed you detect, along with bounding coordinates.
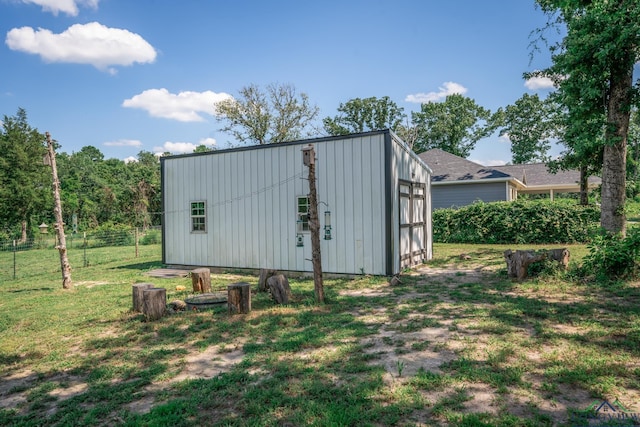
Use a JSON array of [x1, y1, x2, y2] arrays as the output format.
[[0, 109, 161, 240]]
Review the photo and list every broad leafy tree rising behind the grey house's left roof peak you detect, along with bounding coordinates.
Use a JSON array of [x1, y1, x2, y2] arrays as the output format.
[[412, 94, 496, 158]]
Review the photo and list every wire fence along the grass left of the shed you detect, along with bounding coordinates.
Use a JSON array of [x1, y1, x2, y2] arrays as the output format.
[[0, 227, 162, 283]]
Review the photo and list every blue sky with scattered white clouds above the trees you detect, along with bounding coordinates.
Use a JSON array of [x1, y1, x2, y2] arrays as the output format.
[[0, 0, 553, 165]]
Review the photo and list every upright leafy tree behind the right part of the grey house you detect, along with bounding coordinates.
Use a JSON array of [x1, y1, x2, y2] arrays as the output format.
[[497, 93, 558, 164]]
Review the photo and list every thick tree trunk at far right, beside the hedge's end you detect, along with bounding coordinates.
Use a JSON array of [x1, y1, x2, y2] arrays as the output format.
[[600, 50, 635, 235]]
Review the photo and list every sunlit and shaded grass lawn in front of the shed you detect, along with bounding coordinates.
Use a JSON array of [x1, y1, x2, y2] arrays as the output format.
[[0, 244, 640, 426]]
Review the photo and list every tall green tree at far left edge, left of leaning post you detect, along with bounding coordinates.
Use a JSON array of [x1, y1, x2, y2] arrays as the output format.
[[0, 108, 52, 241]]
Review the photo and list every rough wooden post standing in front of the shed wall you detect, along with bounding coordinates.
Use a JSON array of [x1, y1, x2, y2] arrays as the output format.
[[302, 144, 324, 303]]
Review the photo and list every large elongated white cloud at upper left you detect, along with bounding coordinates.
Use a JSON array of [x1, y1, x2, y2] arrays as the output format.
[[5, 22, 156, 74]]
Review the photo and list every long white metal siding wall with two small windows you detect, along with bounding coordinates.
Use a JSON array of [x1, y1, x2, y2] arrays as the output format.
[[163, 133, 389, 274]]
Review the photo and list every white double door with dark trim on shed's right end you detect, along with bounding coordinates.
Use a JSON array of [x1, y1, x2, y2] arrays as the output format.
[[400, 180, 427, 269]]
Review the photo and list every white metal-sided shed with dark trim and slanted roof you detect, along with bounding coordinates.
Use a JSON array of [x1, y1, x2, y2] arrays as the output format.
[[161, 130, 432, 275]]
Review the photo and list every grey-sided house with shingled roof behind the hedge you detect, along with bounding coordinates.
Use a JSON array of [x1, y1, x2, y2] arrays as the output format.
[[419, 148, 601, 209]]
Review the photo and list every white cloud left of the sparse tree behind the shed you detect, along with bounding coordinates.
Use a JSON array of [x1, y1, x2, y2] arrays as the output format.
[[122, 88, 231, 122]]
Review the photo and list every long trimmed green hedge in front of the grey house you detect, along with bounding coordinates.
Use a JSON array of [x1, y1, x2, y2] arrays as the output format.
[[433, 200, 600, 244]]
